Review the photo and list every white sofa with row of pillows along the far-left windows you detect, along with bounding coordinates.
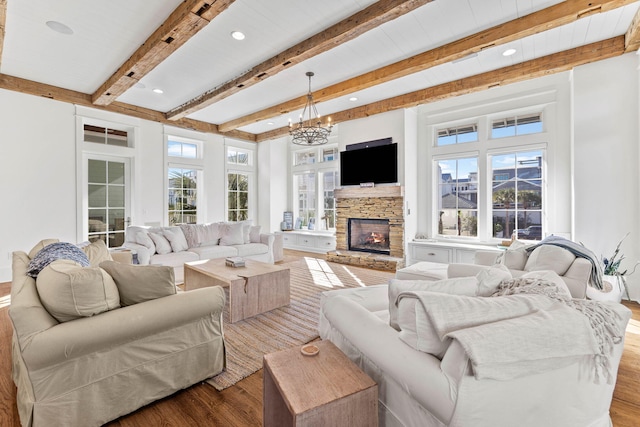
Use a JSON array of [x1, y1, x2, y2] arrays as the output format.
[[123, 221, 275, 282]]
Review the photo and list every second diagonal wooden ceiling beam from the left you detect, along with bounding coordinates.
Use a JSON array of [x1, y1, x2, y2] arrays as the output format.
[[167, 0, 433, 120]]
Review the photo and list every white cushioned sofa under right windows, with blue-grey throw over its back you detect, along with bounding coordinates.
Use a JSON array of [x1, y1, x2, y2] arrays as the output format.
[[396, 241, 601, 298]]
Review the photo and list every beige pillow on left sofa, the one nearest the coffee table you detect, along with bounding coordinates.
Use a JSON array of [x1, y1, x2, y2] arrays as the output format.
[[100, 261, 176, 306]]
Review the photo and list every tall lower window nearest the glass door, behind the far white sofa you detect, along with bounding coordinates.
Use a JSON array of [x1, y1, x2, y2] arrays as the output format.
[[169, 167, 198, 225]]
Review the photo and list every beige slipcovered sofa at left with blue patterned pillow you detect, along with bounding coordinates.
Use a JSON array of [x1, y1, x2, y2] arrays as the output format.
[[9, 239, 225, 427]]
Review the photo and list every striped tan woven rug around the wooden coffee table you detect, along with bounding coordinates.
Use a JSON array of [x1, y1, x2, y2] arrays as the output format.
[[206, 256, 394, 390]]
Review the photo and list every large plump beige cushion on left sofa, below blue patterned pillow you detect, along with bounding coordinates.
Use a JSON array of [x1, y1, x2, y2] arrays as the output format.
[[36, 259, 120, 322]]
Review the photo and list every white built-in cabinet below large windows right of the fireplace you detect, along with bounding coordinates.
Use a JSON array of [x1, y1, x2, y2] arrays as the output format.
[[407, 240, 500, 265]]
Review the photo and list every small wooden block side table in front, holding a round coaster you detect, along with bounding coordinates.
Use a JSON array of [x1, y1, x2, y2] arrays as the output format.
[[262, 341, 378, 427]]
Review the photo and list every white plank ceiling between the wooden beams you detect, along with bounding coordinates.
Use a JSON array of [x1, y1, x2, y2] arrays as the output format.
[[0, 0, 639, 133]]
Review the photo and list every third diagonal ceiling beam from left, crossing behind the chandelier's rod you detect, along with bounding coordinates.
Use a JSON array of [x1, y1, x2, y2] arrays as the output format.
[[224, 0, 637, 132]]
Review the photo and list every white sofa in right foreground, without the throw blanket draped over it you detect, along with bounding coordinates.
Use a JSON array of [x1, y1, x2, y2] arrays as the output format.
[[319, 273, 631, 427]]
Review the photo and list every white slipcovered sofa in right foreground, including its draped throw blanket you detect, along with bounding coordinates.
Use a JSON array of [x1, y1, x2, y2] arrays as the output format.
[[319, 268, 631, 427]]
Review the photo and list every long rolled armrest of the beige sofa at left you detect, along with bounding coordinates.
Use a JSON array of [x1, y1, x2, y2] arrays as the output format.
[[21, 286, 225, 369]]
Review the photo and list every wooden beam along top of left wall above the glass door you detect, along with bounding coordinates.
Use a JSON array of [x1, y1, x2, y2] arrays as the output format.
[[0, 74, 256, 142]]
